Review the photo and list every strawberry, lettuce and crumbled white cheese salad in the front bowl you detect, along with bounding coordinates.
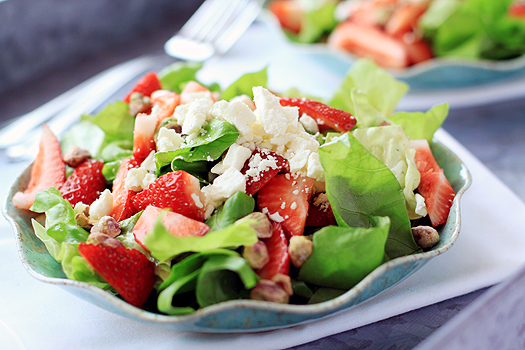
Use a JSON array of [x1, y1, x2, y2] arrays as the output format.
[[12, 60, 455, 315]]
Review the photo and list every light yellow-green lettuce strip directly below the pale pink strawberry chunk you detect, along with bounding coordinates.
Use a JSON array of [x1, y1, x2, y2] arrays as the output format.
[[145, 217, 258, 261]]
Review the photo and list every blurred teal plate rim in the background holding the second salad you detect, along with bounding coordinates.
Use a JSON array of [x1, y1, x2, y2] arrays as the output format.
[[259, 10, 525, 91]]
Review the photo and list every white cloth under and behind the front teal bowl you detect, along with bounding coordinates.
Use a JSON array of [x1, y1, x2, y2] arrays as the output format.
[[0, 22, 525, 350]]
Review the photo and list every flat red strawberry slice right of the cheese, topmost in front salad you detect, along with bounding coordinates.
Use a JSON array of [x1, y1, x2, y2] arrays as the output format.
[[281, 97, 356, 132]]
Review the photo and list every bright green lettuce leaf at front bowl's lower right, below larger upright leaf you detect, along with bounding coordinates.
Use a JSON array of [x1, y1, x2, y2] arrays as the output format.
[[299, 217, 390, 289]]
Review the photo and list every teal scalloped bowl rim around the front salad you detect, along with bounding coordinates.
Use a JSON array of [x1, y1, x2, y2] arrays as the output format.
[[4, 142, 471, 333]]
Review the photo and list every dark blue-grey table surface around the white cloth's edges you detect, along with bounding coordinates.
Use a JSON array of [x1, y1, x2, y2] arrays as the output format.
[[0, 0, 525, 350]]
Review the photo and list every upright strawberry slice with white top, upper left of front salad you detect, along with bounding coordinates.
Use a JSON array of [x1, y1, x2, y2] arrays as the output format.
[[133, 113, 158, 164]]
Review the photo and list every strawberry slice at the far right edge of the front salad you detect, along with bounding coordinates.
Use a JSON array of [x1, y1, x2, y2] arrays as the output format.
[[410, 140, 455, 226]]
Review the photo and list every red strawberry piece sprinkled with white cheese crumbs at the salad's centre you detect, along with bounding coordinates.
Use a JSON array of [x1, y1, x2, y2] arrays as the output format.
[[241, 150, 288, 196]]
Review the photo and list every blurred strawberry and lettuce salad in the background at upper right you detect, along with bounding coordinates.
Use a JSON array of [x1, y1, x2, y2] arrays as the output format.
[[268, 0, 525, 69]]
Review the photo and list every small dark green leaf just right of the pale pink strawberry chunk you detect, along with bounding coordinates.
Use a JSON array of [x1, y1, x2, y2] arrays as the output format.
[[206, 191, 255, 231]]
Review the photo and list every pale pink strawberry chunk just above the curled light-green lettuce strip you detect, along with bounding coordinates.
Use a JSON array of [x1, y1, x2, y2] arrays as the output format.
[[133, 205, 210, 249]]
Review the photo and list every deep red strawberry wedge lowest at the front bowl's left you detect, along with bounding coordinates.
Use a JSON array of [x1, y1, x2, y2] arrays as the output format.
[[78, 243, 155, 307]]
